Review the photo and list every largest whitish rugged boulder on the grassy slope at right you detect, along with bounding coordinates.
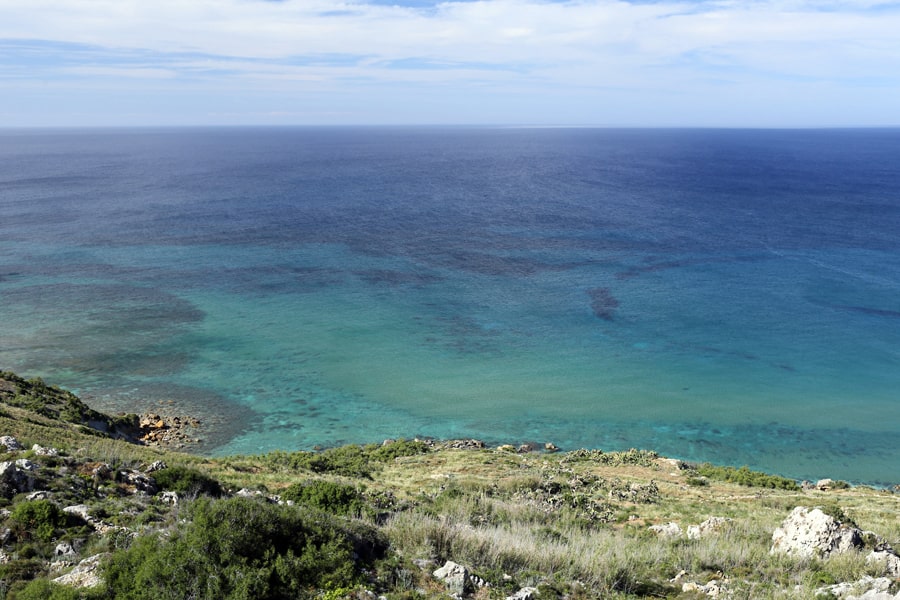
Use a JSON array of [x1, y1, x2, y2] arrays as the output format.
[[769, 506, 863, 557]]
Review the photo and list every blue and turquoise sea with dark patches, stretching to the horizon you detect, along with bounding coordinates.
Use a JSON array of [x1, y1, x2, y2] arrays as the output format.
[[0, 127, 900, 486]]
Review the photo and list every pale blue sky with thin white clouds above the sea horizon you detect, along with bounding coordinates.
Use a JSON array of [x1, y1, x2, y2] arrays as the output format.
[[0, 0, 900, 127]]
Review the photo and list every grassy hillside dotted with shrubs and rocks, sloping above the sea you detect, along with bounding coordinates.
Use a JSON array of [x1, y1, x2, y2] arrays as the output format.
[[0, 374, 900, 600]]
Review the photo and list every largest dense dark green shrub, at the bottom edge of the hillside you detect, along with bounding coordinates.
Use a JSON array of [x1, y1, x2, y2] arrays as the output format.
[[105, 498, 386, 600]]
